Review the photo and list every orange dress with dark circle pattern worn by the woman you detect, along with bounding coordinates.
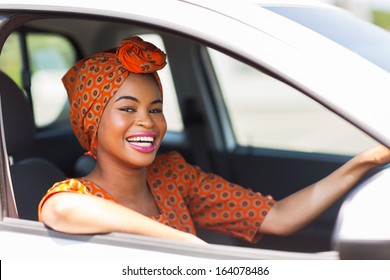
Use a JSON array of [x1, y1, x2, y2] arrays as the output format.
[[38, 152, 274, 242]]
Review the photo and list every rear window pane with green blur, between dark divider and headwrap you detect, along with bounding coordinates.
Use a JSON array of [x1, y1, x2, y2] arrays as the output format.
[[26, 33, 76, 127]]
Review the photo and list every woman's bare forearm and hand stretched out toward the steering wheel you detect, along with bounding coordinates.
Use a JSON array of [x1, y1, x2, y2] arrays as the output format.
[[260, 146, 390, 235]]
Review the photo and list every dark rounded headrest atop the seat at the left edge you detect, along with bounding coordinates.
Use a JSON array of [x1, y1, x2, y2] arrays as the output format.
[[0, 71, 35, 156]]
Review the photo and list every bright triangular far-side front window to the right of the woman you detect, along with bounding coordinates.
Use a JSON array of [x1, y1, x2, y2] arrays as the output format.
[[209, 49, 376, 155]]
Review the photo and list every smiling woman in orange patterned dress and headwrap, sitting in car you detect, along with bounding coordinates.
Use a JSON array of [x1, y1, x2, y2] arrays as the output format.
[[39, 37, 390, 247]]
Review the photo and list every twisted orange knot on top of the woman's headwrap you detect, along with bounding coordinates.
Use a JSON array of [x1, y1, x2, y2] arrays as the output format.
[[117, 36, 166, 73]]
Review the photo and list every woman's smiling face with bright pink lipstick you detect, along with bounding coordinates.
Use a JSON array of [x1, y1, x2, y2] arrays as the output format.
[[97, 73, 167, 168]]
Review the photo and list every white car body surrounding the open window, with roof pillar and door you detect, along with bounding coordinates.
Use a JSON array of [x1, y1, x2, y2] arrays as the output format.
[[0, 0, 390, 260]]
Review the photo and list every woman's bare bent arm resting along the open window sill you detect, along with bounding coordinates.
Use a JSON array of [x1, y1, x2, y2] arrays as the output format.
[[41, 192, 206, 244]]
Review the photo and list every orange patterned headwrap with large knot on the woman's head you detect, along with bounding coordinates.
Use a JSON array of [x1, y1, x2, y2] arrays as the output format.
[[62, 36, 166, 156]]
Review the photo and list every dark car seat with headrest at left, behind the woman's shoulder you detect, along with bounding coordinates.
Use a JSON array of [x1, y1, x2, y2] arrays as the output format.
[[0, 71, 66, 220]]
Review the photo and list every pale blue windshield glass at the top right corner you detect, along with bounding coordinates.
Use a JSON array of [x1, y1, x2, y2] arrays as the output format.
[[264, 7, 390, 72]]
